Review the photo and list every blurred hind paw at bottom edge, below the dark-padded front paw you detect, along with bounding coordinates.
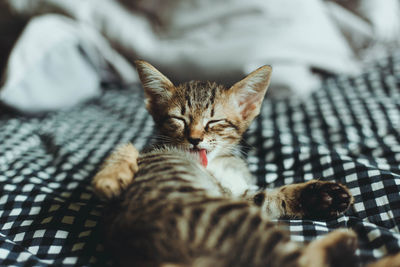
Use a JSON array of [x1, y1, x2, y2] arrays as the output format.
[[299, 229, 358, 267]]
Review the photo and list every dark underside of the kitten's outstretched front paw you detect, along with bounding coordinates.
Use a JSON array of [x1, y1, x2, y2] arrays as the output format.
[[299, 180, 353, 219]]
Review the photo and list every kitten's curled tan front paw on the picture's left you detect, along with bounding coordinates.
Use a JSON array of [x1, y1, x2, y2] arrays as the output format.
[[92, 143, 139, 199]]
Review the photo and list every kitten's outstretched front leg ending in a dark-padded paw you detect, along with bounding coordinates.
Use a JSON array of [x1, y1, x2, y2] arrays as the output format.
[[254, 180, 353, 219]]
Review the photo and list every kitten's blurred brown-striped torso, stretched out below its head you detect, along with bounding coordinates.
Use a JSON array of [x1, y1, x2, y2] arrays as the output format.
[[106, 149, 356, 267]]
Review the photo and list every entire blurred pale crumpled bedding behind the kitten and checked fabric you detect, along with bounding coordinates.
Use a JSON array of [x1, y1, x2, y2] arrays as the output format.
[[0, 0, 400, 113]]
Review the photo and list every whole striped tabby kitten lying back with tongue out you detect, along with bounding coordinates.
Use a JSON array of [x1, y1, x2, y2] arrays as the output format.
[[93, 62, 400, 267]]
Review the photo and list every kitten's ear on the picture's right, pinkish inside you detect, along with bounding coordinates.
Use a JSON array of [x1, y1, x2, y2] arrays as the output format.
[[228, 66, 272, 121]]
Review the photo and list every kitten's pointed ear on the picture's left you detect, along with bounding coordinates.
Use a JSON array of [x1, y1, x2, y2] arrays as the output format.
[[135, 60, 175, 108]]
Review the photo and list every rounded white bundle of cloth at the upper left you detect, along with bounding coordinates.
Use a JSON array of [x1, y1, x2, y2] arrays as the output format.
[[0, 14, 137, 113]]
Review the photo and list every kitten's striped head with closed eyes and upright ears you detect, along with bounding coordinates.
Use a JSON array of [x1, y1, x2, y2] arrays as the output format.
[[136, 61, 272, 158]]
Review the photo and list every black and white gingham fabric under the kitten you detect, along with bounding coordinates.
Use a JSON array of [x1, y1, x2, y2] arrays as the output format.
[[0, 54, 400, 266]]
